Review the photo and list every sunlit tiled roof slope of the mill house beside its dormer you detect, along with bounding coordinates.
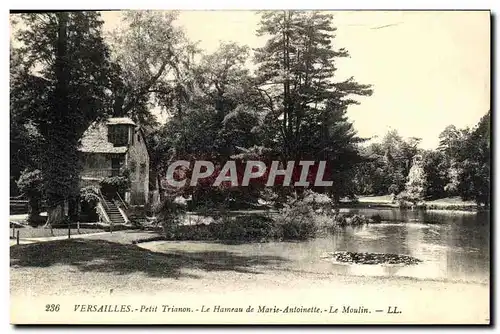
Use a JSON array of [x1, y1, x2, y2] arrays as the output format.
[[80, 123, 128, 154]]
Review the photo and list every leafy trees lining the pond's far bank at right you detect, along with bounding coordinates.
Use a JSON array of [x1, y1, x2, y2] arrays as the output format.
[[355, 112, 491, 206]]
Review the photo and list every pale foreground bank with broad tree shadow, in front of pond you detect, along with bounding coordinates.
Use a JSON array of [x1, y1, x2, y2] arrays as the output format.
[[10, 236, 489, 323]]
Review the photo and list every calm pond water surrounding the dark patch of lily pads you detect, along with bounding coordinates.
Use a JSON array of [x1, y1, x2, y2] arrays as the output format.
[[143, 208, 490, 283]]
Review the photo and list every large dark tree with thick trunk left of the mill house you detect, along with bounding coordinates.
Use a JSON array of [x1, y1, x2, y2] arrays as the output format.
[[13, 12, 111, 225]]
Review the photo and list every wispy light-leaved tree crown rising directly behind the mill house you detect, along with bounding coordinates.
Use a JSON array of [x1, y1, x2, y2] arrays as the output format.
[[110, 10, 199, 125]]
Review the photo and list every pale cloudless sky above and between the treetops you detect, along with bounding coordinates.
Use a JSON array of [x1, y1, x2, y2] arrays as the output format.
[[13, 11, 490, 148]]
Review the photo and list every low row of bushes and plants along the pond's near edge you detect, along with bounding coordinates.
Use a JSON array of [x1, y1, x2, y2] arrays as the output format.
[[160, 193, 381, 243]]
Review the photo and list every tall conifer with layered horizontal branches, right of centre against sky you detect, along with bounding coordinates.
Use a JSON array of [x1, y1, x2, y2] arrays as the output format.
[[255, 11, 372, 201]]
